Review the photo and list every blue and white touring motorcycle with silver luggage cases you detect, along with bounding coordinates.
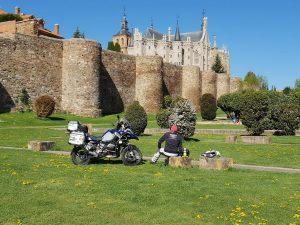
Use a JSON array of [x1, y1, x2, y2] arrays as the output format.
[[67, 116, 142, 166]]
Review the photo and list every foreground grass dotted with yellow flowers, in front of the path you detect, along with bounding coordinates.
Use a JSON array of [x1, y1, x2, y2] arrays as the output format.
[[0, 150, 300, 225]]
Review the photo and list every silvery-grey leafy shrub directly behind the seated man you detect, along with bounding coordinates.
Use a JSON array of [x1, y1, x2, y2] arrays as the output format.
[[169, 99, 197, 139]]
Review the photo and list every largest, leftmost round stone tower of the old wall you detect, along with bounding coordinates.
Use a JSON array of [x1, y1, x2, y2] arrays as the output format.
[[61, 38, 101, 117]]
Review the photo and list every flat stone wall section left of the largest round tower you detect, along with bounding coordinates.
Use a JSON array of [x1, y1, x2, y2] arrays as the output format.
[[0, 34, 63, 110]]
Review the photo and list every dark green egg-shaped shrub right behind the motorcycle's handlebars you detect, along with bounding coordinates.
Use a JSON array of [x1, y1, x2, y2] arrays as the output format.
[[124, 101, 147, 135]]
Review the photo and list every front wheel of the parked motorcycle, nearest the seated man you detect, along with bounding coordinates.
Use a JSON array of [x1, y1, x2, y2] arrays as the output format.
[[121, 145, 143, 166]]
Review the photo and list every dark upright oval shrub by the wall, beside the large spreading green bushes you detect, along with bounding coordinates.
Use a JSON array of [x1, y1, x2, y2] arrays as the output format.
[[201, 94, 217, 120]]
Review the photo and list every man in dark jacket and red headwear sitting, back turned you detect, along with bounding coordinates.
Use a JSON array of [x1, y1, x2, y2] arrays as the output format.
[[151, 125, 189, 164]]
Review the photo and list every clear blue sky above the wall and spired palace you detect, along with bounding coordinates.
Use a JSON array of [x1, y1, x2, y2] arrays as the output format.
[[0, 0, 300, 88]]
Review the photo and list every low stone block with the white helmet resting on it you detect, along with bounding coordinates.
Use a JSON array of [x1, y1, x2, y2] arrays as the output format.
[[199, 156, 233, 170]]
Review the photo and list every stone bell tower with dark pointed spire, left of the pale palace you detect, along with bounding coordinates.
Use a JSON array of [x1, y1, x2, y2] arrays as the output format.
[[112, 10, 132, 54]]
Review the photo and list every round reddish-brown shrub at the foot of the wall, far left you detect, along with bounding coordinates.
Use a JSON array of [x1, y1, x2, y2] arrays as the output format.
[[35, 95, 55, 118]]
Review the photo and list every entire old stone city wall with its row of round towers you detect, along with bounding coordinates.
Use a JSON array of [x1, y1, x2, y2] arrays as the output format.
[[0, 34, 239, 117]]
